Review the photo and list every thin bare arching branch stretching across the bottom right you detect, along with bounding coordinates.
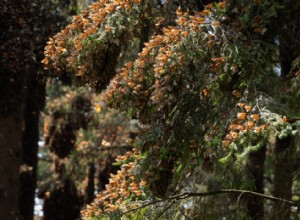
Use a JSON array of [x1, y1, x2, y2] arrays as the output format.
[[124, 189, 298, 214]]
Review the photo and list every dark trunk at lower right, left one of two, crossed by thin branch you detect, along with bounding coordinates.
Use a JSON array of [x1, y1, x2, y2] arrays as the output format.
[[247, 146, 266, 219]]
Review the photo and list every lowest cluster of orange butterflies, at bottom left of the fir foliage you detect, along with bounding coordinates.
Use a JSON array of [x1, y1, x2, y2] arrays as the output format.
[[81, 148, 147, 218]]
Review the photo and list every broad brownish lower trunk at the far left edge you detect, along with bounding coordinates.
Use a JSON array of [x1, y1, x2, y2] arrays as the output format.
[[0, 114, 22, 220]]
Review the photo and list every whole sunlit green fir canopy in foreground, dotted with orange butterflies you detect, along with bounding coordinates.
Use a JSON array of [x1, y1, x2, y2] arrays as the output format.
[[43, 0, 300, 219]]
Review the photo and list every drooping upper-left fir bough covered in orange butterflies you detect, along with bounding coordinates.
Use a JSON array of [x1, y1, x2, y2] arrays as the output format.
[[42, 0, 142, 91]]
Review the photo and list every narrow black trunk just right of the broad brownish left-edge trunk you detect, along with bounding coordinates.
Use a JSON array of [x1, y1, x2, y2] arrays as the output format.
[[19, 79, 45, 220]]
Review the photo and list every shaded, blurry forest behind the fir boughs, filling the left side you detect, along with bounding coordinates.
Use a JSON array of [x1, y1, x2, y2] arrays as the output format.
[[0, 0, 137, 219]]
